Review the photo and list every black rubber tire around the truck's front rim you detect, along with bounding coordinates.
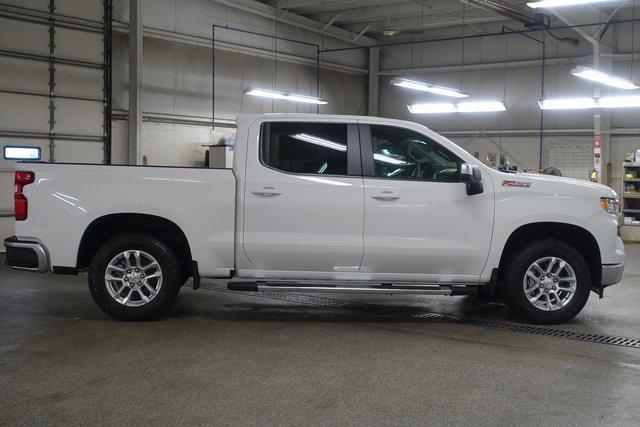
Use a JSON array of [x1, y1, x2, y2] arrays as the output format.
[[501, 239, 591, 324]]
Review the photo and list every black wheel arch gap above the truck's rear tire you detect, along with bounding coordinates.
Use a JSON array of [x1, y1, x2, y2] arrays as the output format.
[[76, 213, 197, 279]]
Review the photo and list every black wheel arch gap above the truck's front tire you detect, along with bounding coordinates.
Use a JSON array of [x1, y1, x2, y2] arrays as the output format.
[[498, 222, 602, 289]]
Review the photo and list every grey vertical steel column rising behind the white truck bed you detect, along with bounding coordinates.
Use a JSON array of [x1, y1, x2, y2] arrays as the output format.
[[127, 0, 142, 165]]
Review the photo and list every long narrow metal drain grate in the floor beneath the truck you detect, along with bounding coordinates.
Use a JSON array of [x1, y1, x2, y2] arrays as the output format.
[[208, 288, 640, 348]]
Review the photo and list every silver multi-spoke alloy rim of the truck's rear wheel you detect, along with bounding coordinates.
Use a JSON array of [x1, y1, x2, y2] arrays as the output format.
[[104, 250, 162, 307]]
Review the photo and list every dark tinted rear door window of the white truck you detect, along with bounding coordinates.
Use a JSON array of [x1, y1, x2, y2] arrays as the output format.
[[262, 122, 347, 175]]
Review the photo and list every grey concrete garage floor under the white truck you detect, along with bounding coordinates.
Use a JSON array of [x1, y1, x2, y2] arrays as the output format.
[[0, 246, 640, 425]]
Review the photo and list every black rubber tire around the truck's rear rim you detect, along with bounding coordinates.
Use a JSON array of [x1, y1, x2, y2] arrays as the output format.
[[89, 233, 183, 321]]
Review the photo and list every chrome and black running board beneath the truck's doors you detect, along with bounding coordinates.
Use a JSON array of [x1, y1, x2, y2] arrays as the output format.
[[227, 282, 480, 296]]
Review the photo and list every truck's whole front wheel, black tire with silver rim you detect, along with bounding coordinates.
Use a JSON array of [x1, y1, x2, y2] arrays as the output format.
[[502, 239, 591, 324]]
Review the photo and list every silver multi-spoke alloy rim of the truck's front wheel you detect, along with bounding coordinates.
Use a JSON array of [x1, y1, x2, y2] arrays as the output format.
[[522, 257, 578, 311]]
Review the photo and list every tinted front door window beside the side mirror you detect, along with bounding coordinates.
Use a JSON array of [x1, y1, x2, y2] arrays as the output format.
[[370, 126, 460, 182]]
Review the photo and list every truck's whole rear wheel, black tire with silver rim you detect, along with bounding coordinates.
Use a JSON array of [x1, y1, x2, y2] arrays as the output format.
[[89, 233, 182, 320]]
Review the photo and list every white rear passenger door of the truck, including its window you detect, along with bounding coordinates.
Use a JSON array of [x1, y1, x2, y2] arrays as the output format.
[[244, 121, 364, 278]]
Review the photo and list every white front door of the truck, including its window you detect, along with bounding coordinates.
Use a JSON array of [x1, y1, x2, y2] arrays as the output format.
[[360, 125, 494, 281]]
